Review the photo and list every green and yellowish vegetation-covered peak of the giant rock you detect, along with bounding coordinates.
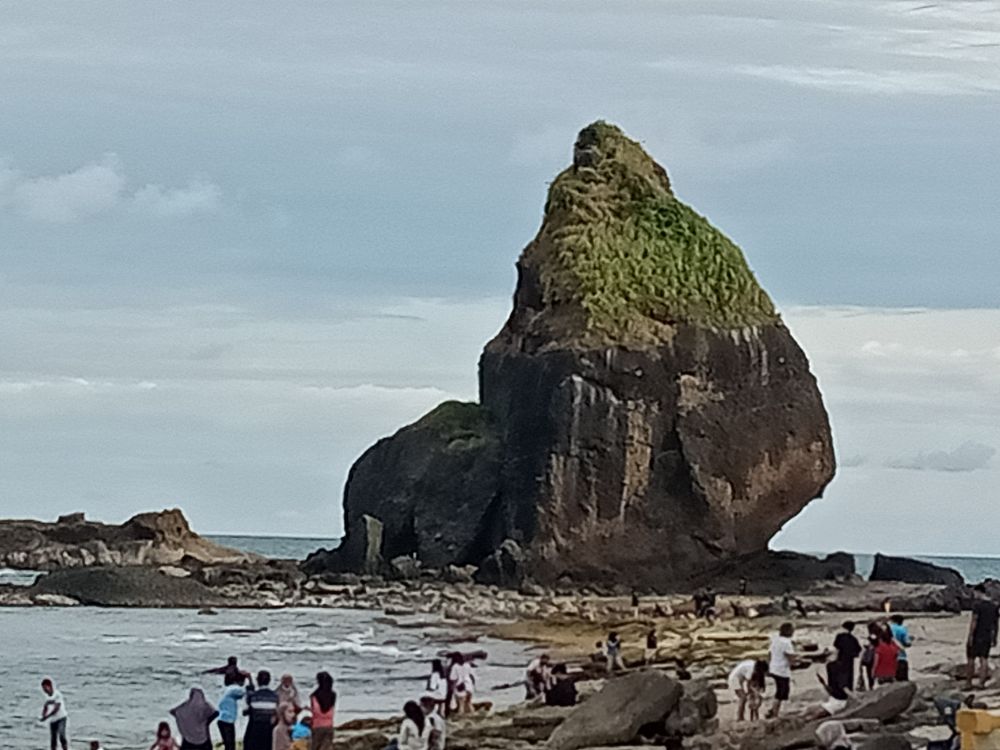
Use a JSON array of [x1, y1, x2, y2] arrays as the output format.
[[521, 122, 778, 342]]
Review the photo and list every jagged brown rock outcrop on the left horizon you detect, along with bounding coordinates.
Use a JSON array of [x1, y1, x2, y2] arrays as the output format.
[[0, 509, 258, 571]]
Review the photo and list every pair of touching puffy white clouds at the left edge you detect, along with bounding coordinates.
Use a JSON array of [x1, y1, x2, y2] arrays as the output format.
[[0, 153, 222, 224]]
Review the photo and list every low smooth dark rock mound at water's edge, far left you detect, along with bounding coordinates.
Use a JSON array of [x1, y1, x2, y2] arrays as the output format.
[[28, 566, 223, 607]]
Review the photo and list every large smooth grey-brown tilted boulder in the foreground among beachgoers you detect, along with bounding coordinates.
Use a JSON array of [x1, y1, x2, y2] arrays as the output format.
[[545, 670, 682, 750]]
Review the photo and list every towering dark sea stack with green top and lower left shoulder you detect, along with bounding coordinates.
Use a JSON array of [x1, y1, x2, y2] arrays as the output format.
[[309, 122, 834, 587]]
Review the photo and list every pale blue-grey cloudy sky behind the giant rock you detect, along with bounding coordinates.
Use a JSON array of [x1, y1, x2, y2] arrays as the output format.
[[0, 0, 1000, 554]]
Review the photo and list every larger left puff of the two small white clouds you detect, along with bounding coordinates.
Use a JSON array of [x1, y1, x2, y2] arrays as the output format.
[[7, 154, 125, 224]]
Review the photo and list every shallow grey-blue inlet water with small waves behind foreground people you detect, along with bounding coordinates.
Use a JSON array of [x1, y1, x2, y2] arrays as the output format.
[[0, 607, 531, 750]]
